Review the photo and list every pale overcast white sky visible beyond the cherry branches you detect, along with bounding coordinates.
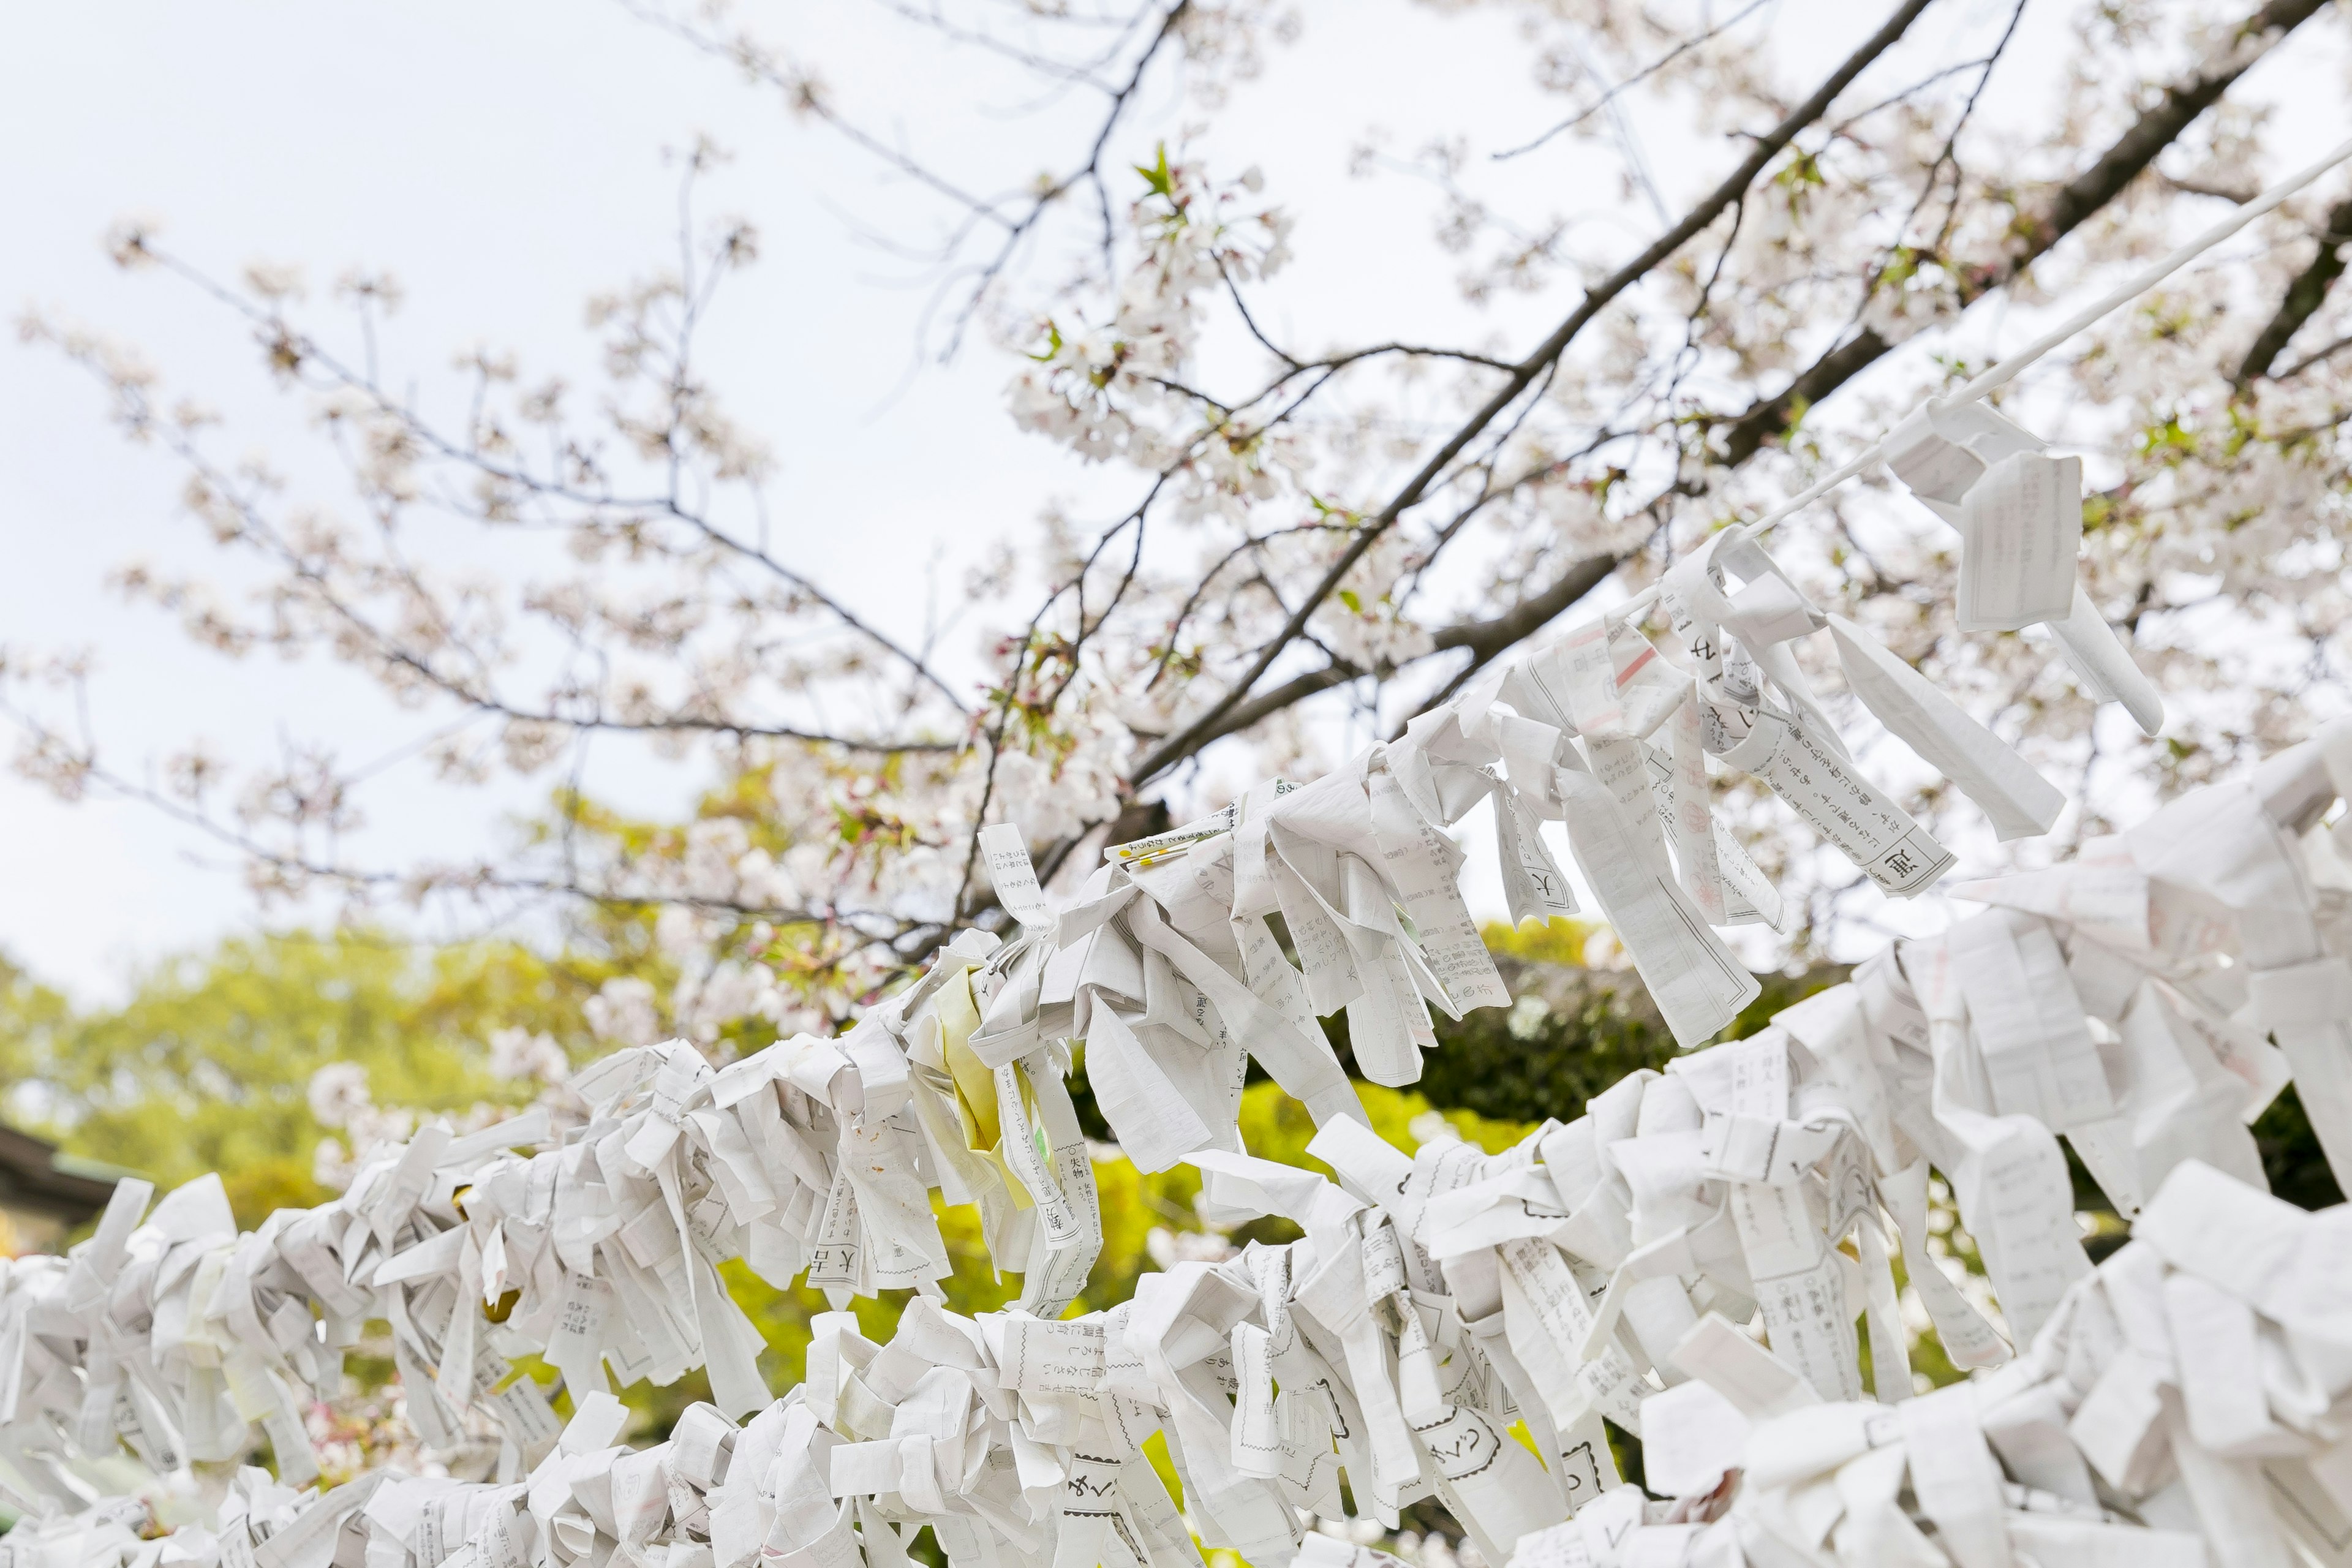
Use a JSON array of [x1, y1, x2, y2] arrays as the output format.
[[0, 0, 2340, 997]]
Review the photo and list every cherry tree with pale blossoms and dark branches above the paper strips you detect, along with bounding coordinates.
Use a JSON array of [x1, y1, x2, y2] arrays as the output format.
[[9, 0, 2352, 1039]]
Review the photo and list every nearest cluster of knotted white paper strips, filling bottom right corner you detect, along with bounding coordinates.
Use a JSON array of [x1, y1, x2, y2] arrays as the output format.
[[1517, 1161, 2352, 1568]]
